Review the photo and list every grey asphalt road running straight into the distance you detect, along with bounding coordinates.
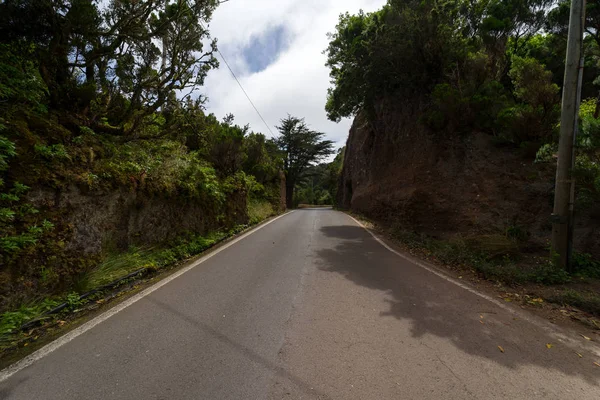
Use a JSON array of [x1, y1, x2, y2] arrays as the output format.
[[0, 210, 600, 400]]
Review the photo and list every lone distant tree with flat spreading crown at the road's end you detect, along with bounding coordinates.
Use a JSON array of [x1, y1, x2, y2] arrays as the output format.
[[275, 115, 333, 208]]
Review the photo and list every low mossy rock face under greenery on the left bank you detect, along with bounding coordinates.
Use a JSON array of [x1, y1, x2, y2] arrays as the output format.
[[29, 186, 248, 254]]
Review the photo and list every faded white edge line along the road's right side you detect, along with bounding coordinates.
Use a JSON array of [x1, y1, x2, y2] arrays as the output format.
[[343, 213, 600, 357]]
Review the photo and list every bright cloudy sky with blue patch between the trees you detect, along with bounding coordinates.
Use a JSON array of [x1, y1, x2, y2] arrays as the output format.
[[203, 0, 385, 146]]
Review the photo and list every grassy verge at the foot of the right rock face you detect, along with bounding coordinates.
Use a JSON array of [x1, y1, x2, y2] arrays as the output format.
[[382, 222, 600, 323]]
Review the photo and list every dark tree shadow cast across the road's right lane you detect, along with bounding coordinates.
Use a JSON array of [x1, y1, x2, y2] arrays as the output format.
[[316, 225, 600, 385]]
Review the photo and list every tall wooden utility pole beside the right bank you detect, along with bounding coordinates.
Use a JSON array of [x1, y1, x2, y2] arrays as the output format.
[[552, 0, 585, 269]]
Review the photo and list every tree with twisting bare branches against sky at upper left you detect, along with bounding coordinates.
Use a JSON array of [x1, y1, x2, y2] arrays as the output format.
[[0, 0, 219, 134]]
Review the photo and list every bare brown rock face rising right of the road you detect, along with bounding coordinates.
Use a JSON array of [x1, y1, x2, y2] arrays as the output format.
[[337, 103, 600, 256]]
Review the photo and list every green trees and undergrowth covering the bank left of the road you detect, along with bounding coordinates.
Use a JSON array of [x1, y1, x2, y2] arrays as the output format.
[[0, 0, 292, 324]]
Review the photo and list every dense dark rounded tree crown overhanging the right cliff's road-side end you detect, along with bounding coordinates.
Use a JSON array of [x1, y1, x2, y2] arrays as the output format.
[[325, 0, 468, 121]]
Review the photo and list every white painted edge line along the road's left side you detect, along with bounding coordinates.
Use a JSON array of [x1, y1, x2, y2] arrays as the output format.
[[0, 210, 294, 382]]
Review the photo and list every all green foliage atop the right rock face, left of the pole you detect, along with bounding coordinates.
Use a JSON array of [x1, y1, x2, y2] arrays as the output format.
[[325, 0, 565, 145]]
